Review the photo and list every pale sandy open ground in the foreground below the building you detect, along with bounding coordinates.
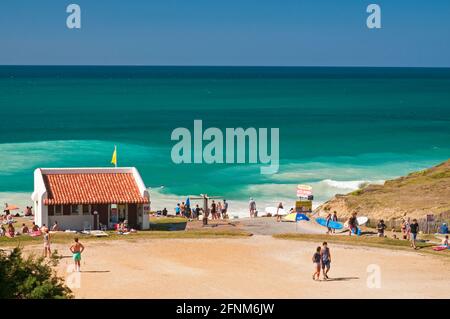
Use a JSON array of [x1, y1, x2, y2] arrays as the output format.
[[15, 224, 450, 298]]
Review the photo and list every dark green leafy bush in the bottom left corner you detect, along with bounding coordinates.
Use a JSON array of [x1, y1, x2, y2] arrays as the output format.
[[0, 248, 73, 299]]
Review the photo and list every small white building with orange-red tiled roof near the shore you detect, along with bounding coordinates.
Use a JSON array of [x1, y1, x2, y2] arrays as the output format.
[[31, 167, 150, 230]]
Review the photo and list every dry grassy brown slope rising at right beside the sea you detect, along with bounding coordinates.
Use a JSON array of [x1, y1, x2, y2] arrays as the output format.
[[316, 159, 450, 220]]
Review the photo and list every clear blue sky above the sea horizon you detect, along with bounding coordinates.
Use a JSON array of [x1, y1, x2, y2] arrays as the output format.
[[0, 0, 450, 67]]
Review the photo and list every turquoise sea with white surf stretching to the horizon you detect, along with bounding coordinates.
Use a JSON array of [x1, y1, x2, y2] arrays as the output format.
[[0, 66, 450, 214]]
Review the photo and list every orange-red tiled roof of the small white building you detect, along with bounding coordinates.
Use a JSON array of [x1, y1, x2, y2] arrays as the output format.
[[43, 173, 148, 205]]
